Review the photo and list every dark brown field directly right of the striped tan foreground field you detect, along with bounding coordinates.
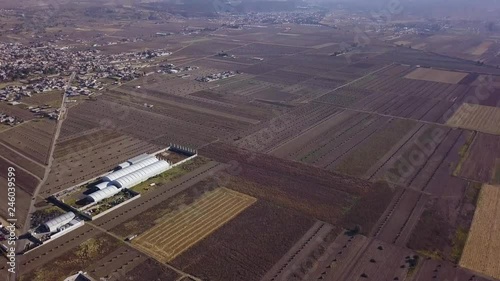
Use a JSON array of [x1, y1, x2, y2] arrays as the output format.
[[172, 200, 314, 281]]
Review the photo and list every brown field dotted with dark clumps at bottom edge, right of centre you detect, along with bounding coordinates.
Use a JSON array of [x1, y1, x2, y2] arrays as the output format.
[[270, 229, 421, 281]]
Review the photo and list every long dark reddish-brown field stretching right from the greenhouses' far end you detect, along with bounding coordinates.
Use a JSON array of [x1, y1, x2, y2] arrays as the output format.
[[200, 142, 393, 233]]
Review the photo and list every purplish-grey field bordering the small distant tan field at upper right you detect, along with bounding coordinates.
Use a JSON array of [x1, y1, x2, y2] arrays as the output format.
[[315, 65, 474, 123]]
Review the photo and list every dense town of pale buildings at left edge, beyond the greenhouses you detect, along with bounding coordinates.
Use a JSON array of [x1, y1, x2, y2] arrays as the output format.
[[0, 43, 177, 122]]
